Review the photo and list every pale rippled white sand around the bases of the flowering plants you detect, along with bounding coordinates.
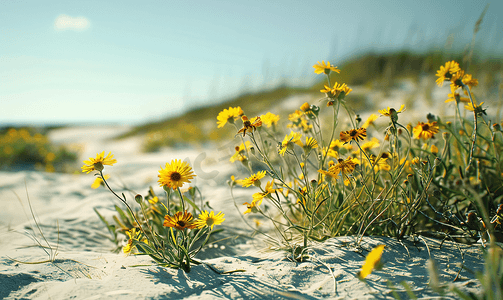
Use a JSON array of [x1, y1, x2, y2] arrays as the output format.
[[0, 123, 483, 299]]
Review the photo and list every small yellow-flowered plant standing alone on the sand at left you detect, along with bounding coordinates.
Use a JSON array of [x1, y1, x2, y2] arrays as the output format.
[[86, 151, 225, 272]]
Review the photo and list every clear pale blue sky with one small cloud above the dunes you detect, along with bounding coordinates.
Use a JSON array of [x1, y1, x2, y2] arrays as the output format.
[[0, 0, 503, 125]]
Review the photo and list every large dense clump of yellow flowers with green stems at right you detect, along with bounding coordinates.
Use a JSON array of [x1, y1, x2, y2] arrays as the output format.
[[217, 61, 503, 258]]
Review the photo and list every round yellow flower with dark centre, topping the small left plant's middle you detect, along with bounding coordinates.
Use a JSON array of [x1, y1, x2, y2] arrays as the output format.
[[157, 159, 196, 190]]
